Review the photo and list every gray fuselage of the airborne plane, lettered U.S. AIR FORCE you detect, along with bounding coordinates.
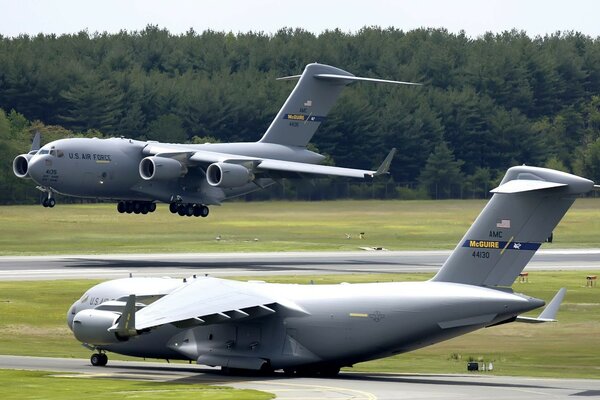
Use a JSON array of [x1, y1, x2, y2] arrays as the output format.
[[27, 138, 323, 204]]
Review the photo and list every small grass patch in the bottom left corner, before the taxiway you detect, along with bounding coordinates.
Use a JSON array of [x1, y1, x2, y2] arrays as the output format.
[[0, 370, 274, 400]]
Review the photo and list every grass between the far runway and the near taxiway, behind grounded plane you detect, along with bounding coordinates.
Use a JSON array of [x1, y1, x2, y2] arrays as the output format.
[[0, 271, 600, 378]]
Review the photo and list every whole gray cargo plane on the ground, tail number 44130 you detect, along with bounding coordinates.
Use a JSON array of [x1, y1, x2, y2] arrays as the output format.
[[67, 166, 594, 376]]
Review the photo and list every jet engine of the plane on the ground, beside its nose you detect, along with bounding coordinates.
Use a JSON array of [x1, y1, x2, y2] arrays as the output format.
[[73, 308, 127, 345]]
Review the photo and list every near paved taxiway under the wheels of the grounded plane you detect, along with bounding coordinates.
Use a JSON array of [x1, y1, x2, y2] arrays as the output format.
[[0, 356, 600, 400]]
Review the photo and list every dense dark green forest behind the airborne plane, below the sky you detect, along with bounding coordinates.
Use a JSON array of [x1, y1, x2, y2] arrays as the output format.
[[0, 26, 600, 203]]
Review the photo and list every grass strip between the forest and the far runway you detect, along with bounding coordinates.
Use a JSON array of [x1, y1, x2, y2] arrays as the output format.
[[0, 198, 600, 255]]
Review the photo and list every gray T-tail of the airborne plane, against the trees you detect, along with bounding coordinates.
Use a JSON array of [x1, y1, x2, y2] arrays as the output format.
[[260, 63, 419, 147]]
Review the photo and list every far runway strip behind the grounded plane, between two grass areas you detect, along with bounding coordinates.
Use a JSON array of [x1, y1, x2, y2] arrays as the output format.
[[0, 249, 600, 280]]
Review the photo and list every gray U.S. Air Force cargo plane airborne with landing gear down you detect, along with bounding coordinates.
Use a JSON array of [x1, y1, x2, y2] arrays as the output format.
[[13, 63, 417, 217]]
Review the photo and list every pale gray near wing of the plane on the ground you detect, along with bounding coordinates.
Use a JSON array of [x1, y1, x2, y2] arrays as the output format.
[[135, 277, 306, 331]]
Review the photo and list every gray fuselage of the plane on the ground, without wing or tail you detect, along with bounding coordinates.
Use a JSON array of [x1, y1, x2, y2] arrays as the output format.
[[67, 277, 544, 369]]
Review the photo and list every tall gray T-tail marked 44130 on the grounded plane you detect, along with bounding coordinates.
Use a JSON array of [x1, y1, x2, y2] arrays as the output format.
[[432, 166, 594, 287]]
